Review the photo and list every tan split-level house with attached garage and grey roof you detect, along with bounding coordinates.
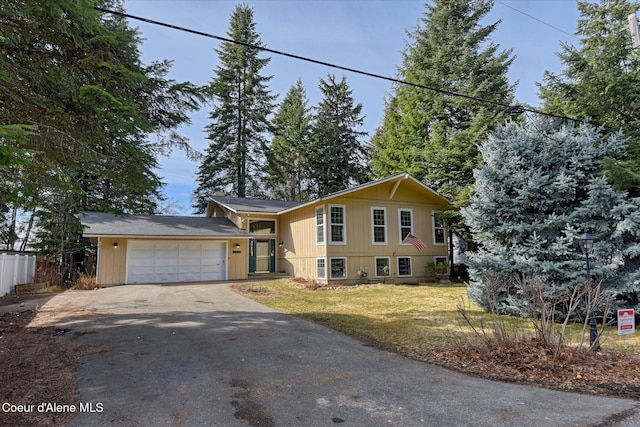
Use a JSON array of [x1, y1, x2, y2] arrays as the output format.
[[81, 173, 449, 285]]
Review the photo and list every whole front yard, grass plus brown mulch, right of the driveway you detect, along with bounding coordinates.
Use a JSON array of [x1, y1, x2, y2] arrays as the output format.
[[235, 280, 640, 399]]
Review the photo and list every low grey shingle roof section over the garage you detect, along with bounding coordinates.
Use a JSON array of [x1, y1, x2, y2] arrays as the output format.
[[80, 212, 249, 238]]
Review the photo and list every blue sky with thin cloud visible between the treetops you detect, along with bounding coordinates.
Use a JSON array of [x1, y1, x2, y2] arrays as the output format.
[[125, 0, 578, 215]]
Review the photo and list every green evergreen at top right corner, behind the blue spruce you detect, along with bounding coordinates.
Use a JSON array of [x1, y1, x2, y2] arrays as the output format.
[[539, 0, 640, 197]]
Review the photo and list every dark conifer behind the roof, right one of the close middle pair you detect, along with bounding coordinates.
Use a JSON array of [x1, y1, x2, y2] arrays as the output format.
[[308, 74, 367, 196]]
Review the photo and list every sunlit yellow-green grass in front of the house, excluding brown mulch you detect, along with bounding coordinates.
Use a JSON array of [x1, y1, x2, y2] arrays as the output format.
[[236, 279, 640, 354]]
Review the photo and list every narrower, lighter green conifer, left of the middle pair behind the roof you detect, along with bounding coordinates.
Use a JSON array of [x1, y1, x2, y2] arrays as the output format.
[[267, 79, 311, 201]]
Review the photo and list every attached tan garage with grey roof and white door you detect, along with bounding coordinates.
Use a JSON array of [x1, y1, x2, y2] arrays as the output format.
[[80, 212, 249, 285]]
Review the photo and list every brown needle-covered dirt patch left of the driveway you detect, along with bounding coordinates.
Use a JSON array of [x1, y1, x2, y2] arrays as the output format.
[[0, 294, 105, 427]]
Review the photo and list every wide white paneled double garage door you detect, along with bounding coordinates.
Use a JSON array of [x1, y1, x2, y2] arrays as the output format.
[[127, 240, 227, 283]]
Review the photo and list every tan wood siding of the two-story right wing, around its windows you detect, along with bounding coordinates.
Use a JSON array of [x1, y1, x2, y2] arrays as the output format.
[[279, 183, 448, 283]]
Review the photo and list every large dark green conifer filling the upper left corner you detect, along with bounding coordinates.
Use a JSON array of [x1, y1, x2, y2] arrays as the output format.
[[0, 0, 203, 274]]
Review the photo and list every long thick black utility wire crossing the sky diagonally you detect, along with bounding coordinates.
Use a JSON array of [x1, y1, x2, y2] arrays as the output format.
[[94, 6, 578, 122]]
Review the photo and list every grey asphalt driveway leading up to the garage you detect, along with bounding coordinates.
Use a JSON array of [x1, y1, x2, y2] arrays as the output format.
[[36, 283, 640, 427]]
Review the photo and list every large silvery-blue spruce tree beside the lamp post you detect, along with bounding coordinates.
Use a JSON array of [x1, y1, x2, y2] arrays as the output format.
[[462, 121, 640, 315]]
